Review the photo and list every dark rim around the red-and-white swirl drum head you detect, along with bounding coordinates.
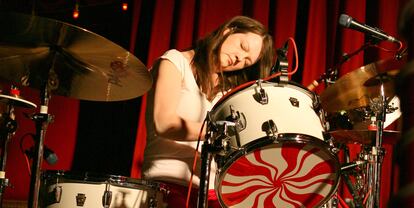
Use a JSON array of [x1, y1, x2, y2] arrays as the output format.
[[214, 133, 341, 207]]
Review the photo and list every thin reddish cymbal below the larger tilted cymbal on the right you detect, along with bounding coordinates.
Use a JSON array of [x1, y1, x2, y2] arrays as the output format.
[[329, 130, 400, 145]]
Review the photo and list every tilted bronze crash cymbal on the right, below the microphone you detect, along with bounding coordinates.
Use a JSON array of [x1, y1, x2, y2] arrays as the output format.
[[320, 58, 404, 112]]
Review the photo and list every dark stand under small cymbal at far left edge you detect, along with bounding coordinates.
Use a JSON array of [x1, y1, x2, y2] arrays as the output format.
[[0, 104, 17, 206]]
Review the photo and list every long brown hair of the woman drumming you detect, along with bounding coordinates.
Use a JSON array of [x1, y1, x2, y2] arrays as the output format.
[[192, 16, 274, 99]]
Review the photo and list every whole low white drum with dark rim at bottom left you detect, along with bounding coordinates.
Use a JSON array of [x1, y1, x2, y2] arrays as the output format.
[[41, 171, 168, 208]]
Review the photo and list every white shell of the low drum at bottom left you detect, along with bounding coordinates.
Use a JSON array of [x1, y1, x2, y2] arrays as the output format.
[[43, 174, 167, 208]]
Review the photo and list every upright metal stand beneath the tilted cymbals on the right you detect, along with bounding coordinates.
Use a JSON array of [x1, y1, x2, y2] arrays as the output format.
[[366, 79, 387, 208]]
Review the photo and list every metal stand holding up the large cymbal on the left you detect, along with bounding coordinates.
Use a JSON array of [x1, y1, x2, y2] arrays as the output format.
[[29, 83, 53, 208]]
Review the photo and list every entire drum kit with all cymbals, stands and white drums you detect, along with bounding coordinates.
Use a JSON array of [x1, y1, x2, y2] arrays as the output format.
[[0, 10, 408, 208]]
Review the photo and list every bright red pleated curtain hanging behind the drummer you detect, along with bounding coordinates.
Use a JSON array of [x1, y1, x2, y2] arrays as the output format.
[[131, 0, 406, 207]]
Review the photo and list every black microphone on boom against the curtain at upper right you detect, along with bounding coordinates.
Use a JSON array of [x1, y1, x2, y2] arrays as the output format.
[[339, 14, 400, 43]]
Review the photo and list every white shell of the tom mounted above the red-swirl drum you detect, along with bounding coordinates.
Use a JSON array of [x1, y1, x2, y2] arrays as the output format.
[[212, 82, 324, 146]]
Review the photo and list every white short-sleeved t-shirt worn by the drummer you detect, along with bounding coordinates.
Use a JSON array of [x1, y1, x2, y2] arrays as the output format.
[[142, 49, 221, 189]]
